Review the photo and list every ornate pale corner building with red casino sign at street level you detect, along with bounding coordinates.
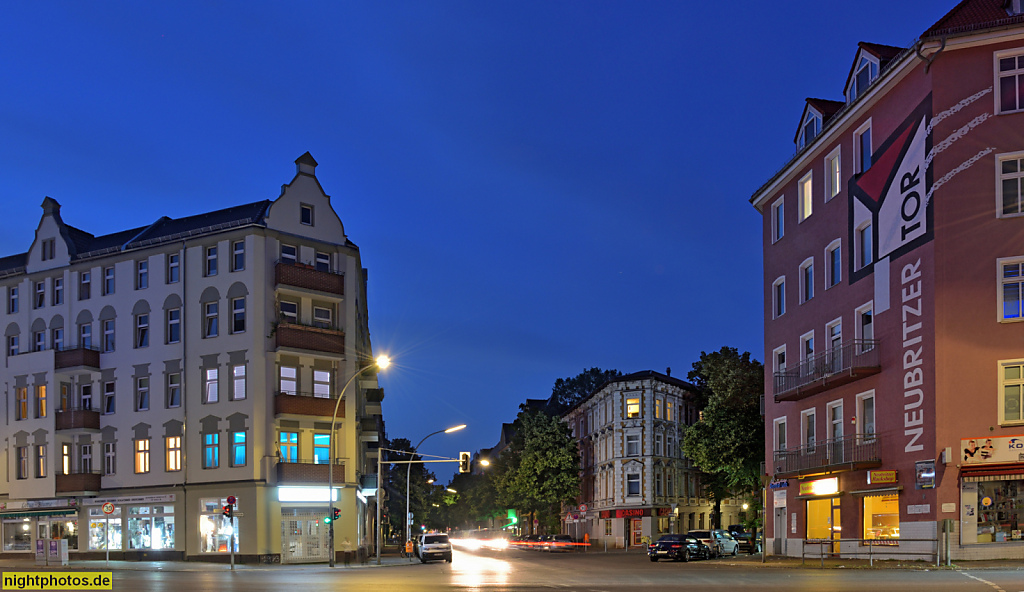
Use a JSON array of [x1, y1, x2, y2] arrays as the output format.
[[562, 370, 743, 548]]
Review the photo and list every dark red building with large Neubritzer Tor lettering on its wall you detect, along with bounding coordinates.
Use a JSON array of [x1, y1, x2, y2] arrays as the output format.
[[751, 0, 1024, 560]]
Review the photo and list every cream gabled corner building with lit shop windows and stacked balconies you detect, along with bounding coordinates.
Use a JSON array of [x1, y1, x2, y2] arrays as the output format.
[[0, 153, 383, 562]]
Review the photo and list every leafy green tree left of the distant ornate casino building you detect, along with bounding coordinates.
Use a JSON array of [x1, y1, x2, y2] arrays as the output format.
[[495, 406, 580, 524]]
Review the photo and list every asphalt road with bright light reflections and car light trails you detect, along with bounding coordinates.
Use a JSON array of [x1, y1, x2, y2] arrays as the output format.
[[3, 550, 1024, 592]]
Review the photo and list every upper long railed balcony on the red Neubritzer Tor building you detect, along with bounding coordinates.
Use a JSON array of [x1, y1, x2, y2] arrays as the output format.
[[773, 339, 882, 403]]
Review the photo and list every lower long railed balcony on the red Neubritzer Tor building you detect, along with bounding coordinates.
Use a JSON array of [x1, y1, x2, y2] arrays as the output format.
[[772, 435, 882, 478]]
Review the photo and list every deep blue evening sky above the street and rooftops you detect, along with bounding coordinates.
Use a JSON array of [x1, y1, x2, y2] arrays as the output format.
[[0, 0, 955, 478]]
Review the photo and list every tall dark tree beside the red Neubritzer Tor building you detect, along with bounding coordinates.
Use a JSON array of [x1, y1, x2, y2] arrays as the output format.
[[683, 347, 764, 527]]
